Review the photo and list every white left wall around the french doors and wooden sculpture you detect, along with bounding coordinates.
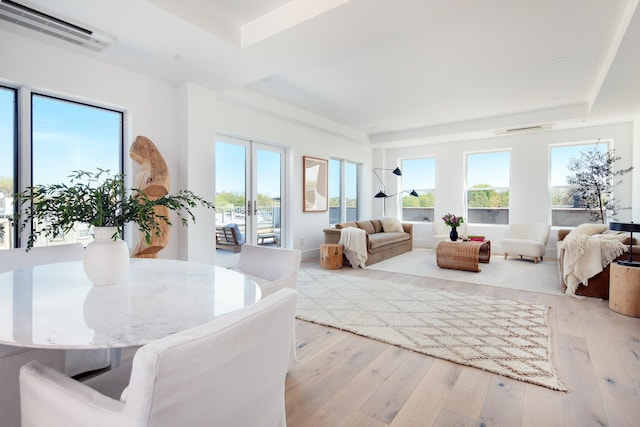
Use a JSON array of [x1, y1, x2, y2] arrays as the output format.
[[0, 30, 371, 262]]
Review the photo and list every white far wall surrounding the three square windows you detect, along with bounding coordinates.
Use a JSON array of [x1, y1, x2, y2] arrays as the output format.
[[374, 121, 640, 257]]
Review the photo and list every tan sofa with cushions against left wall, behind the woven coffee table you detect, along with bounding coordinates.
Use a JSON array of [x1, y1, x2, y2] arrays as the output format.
[[324, 219, 413, 265]]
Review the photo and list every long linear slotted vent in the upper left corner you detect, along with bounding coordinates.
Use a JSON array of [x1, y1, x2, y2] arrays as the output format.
[[0, 0, 114, 52]]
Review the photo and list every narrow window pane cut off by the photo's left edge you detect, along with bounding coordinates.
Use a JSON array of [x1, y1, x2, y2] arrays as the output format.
[[0, 87, 17, 249]]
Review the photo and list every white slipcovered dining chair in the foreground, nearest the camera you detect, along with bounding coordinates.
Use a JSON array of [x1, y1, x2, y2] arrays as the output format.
[[20, 289, 296, 427]]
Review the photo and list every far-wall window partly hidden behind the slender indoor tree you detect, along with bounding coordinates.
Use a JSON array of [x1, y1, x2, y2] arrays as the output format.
[[549, 141, 609, 227]]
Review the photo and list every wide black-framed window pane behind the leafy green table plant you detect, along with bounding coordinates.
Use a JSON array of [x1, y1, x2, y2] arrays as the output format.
[[31, 94, 123, 246]]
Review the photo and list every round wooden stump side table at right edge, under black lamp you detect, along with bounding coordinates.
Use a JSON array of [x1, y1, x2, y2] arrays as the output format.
[[609, 262, 640, 317]]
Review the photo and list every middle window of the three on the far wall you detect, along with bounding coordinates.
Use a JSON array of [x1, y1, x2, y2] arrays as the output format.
[[466, 151, 511, 224]]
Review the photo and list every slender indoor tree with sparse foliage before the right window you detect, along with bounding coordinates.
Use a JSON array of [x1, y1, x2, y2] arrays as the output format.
[[567, 146, 633, 224]]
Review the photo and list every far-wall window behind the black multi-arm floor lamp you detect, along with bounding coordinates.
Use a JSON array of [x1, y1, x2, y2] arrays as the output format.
[[400, 157, 436, 221]]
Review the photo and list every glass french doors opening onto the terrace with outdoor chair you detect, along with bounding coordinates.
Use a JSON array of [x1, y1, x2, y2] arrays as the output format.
[[215, 135, 286, 246]]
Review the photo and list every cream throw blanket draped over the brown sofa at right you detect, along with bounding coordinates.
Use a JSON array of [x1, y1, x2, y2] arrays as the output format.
[[561, 234, 627, 295]]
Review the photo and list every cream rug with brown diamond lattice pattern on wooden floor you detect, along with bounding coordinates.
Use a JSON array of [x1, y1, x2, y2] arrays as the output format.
[[296, 271, 568, 391]]
